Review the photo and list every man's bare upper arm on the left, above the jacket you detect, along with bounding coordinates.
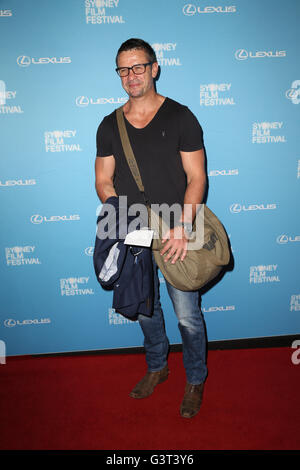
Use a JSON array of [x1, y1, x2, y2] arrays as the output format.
[[95, 155, 117, 203]]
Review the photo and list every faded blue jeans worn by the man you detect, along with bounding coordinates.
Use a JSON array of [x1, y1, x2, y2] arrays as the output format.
[[138, 255, 207, 385]]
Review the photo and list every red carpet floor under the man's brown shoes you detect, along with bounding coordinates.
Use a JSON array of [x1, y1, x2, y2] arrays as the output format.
[[0, 348, 300, 450]]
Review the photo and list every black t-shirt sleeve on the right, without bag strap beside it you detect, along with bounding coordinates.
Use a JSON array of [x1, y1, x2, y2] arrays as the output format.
[[179, 107, 203, 152]]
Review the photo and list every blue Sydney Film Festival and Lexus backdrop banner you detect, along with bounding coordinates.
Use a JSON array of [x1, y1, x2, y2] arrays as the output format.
[[0, 0, 300, 355]]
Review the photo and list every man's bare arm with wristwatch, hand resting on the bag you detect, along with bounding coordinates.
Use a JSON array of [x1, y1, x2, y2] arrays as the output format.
[[161, 149, 206, 263]]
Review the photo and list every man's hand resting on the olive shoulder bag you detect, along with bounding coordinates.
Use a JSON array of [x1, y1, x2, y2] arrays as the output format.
[[160, 226, 188, 264]]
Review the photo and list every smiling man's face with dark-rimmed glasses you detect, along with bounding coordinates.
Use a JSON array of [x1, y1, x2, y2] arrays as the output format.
[[118, 49, 158, 98]]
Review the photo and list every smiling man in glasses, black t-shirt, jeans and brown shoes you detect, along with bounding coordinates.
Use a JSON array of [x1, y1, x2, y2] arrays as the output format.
[[95, 39, 207, 418]]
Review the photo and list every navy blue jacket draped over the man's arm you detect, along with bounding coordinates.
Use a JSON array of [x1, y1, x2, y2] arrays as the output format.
[[93, 196, 153, 320]]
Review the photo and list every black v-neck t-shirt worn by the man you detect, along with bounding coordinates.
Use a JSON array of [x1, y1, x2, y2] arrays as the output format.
[[97, 98, 203, 206]]
